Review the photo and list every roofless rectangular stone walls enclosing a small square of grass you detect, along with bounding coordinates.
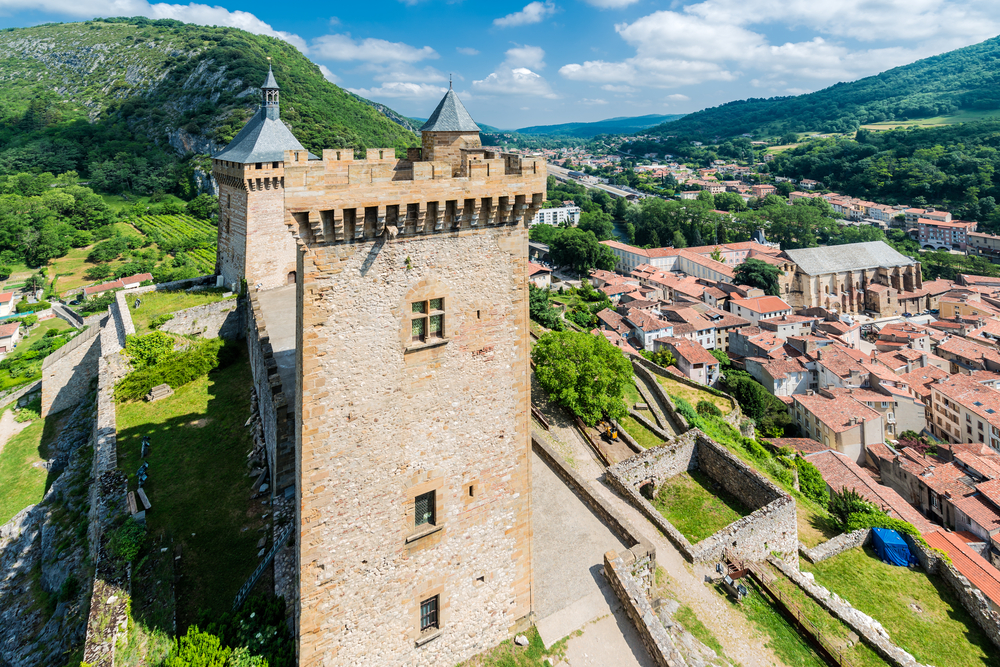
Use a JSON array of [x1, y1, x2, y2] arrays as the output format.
[[607, 429, 798, 563]]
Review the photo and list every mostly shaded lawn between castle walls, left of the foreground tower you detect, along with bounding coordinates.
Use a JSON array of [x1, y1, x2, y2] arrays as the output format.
[[118, 353, 270, 633]]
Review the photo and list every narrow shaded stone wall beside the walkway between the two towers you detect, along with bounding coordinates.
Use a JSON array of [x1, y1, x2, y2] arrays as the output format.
[[246, 290, 295, 491]]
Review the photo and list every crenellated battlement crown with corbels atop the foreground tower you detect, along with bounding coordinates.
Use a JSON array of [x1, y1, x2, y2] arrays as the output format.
[[282, 148, 546, 245]]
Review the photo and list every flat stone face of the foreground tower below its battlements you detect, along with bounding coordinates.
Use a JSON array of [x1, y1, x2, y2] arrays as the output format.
[[294, 226, 544, 666]]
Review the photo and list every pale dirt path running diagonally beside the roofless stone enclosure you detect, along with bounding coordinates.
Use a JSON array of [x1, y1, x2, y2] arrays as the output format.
[[532, 374, 784, 667]]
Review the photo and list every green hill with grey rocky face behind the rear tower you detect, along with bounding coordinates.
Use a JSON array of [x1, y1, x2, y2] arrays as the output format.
[[0, 18, 416, 198]]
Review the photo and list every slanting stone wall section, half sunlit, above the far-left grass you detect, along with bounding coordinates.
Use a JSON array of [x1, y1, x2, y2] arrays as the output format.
[[42, 324, 101, 417]]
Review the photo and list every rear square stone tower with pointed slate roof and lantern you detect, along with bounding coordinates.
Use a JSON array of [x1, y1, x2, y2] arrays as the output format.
[[212, 68, 315, 289]]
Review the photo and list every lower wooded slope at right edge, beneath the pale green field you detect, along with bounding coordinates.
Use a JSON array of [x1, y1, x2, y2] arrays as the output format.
[[770, 120, 1000, 233]]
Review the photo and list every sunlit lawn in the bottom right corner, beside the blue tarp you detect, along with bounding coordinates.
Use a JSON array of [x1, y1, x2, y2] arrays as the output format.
[[801, 547, 1000, 667]]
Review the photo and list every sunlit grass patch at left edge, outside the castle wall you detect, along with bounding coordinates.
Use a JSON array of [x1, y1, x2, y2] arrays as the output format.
[[0, 410, 66, 524]]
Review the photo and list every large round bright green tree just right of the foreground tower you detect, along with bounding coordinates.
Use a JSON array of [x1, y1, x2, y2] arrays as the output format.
[[531, 331, 632, 425]]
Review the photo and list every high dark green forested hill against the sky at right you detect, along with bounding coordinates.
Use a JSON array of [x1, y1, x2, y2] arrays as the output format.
[[649, 37, 1000, 138]]
